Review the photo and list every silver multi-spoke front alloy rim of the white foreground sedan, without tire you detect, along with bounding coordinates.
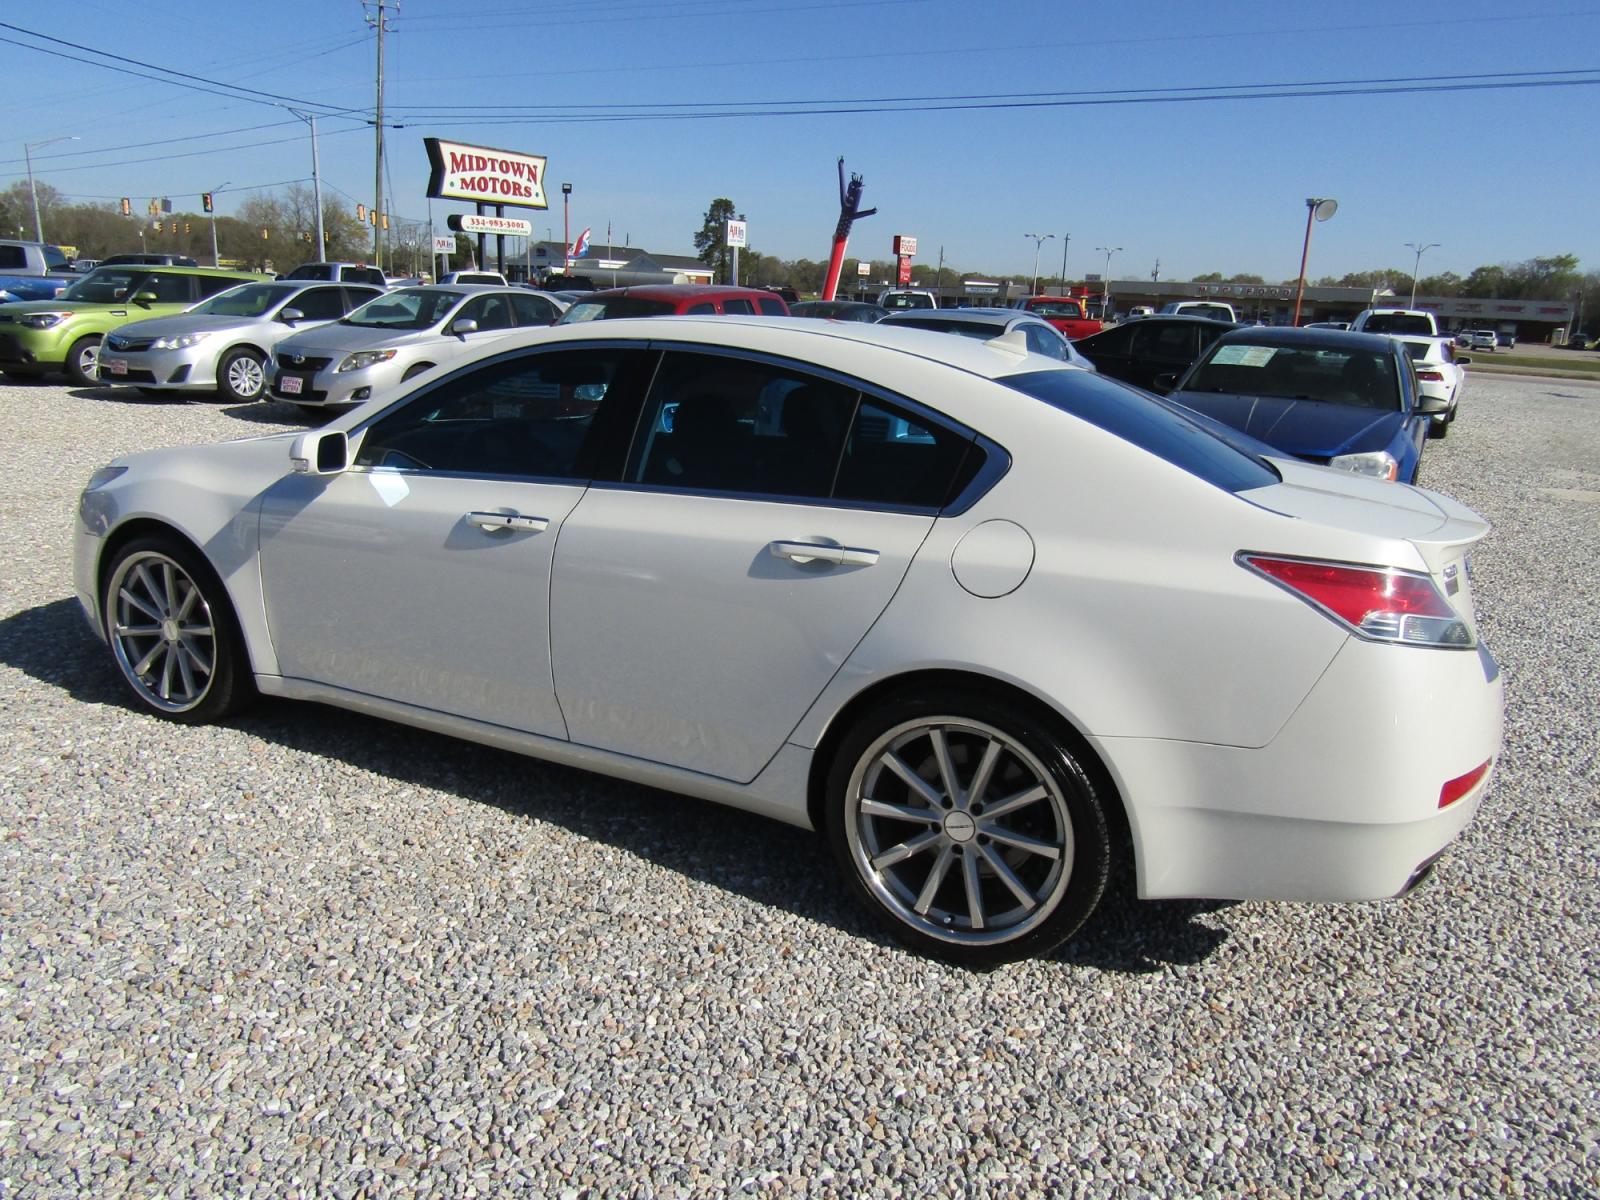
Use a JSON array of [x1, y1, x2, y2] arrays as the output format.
[[106, 550, 216, 712]]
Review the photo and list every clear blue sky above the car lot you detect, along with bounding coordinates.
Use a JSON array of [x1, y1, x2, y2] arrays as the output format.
[[0, 0, 1600, 280]]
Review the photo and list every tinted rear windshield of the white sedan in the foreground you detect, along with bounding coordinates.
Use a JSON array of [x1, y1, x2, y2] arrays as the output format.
[[998, 371, 1278, 491]]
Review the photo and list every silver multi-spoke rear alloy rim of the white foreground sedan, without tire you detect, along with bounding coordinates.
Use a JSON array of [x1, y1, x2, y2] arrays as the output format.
[[845, 717, 1074, 946]]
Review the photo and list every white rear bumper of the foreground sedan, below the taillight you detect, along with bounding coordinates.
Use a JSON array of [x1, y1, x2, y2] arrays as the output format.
[[1098, 638, 1502, 901]]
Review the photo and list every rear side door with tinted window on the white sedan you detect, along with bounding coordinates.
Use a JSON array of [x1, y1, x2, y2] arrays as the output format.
[[550, 349, 971, 782]]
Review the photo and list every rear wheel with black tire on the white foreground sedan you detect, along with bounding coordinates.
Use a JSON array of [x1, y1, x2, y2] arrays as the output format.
[[822, 688, 1112, 968]]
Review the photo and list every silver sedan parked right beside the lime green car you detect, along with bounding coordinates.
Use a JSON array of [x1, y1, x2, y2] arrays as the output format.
[[99, 280, 384, 402]]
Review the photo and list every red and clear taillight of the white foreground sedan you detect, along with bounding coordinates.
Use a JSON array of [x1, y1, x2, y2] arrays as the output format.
[[1237, 552, 1474, 648]]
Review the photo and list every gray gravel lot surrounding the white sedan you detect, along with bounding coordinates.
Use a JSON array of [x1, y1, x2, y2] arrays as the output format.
[[0, 376, 1600, 1200]]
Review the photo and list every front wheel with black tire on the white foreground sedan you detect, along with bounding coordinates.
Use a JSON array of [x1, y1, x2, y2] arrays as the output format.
[[102, 534, 256, 725]]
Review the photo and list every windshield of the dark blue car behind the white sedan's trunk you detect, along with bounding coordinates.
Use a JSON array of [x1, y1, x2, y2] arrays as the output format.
[[1182, 341, 1400, 410]]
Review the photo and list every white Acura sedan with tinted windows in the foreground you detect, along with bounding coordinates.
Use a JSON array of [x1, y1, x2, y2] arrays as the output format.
[[75, 318, 1501, 966]]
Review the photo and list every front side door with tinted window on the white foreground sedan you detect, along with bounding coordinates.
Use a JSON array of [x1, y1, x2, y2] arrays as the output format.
[[261, 349, 643, 738]]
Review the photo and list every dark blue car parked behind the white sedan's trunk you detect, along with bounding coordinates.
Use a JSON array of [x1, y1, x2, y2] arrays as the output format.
[[1168, 328, 1438, 483]]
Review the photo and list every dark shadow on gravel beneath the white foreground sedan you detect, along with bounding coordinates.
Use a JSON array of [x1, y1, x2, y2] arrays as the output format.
[[0, 598, 1227, 974]]
